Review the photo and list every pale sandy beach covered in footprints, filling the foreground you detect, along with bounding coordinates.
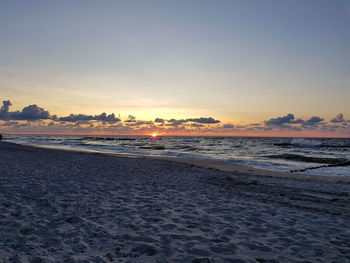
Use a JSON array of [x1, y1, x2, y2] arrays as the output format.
[[0, 142, 350, 263]]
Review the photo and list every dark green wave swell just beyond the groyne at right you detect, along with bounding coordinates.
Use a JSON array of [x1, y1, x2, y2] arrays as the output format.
[[264, 153, 348, 164]]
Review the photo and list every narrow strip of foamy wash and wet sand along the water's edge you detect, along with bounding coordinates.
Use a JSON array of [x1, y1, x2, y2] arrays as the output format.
[[4, 142, 350, 184]]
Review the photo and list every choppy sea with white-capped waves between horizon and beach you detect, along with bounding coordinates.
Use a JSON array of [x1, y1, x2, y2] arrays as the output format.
[[4, 134, 350, 176]]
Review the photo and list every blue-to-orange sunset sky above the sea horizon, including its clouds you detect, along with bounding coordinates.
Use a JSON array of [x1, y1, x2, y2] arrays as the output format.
[[0, 0, 350, 137]]
